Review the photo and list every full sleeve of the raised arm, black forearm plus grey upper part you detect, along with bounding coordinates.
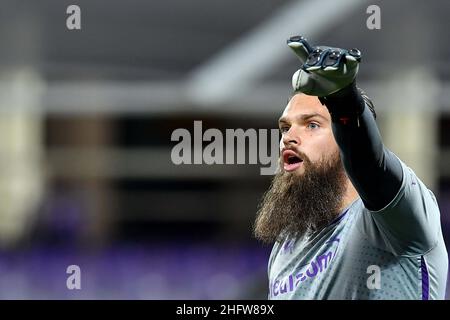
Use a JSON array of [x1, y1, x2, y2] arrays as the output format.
[[321, 84, 441, 255]]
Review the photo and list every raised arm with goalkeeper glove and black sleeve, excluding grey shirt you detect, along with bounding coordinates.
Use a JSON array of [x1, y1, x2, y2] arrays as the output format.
[[288, 36, 403, 211]]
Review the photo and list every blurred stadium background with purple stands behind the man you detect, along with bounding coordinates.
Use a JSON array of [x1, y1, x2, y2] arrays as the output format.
[[0, 0, 450, 299]]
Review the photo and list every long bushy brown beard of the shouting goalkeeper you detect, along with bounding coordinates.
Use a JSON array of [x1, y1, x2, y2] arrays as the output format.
[[254, 152, 347, 244]]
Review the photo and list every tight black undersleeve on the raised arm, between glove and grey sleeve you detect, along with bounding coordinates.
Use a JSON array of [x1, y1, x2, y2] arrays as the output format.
[[322, 84, 402, 210]]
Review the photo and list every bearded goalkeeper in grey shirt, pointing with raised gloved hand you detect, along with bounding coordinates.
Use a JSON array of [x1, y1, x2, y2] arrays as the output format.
[[254, 36, 448, 300]]
